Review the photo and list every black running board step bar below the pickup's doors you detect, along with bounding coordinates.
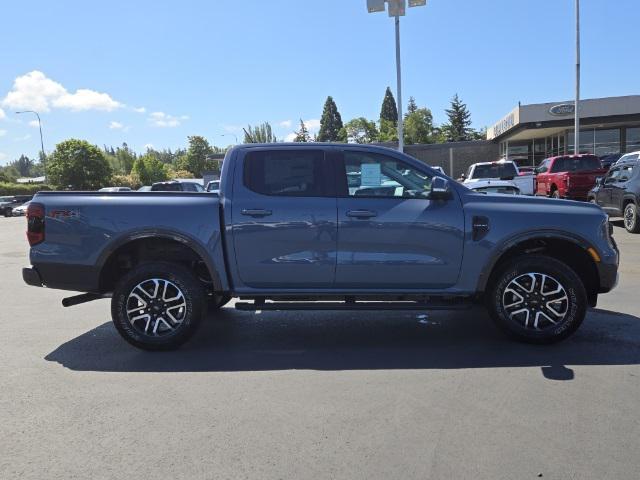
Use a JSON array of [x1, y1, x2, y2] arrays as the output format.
[[235, 300, 472, 311]]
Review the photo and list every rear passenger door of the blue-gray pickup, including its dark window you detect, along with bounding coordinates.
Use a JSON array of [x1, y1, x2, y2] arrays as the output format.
[[231, 147, 337, 290]]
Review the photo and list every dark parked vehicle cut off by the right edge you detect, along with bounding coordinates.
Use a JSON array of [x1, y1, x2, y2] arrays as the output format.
[[589, 157, 640, 233]]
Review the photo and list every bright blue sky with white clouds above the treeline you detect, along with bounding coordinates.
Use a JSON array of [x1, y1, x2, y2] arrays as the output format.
[[0, 0, 640, 164]]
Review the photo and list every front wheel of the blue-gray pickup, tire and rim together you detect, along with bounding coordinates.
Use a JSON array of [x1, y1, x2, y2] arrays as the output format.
[[486, 255, 588, 344]]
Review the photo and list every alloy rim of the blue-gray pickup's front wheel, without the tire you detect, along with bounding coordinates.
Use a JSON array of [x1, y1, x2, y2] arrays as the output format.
[[502, 272, 569, 330]]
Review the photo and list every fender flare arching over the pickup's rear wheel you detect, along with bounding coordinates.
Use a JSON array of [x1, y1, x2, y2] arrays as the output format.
[[96, 228, 222, 291]]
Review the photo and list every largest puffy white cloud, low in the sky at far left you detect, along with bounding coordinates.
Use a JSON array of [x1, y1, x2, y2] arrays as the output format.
[[2, 70, 123, 112]]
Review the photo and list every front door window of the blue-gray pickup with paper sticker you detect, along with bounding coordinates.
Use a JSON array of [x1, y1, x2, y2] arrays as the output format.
[[344, 151, 431, 198]]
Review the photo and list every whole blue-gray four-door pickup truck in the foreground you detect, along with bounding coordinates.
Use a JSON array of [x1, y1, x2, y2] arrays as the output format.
[[23, 143, 619, 350]]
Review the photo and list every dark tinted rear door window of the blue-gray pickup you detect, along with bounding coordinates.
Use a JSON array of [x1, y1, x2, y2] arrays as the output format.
[[244, 149, 330, 197]]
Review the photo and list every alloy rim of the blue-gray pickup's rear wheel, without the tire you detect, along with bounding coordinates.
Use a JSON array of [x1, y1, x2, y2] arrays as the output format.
[[126, 278, 187, 337]]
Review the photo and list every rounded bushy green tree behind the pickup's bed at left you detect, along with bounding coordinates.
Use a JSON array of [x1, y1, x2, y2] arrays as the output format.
[[47, 138, 112, 190]]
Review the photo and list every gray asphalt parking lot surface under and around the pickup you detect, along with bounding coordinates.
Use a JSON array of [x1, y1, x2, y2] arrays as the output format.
[[0, 218, 640, 479]]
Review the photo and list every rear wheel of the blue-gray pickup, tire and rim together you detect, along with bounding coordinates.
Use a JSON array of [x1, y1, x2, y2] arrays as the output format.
[[111, 262, 206, 350]]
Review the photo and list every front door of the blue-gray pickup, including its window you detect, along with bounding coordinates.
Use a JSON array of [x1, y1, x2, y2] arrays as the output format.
[[335, 148, 464, 291]]
